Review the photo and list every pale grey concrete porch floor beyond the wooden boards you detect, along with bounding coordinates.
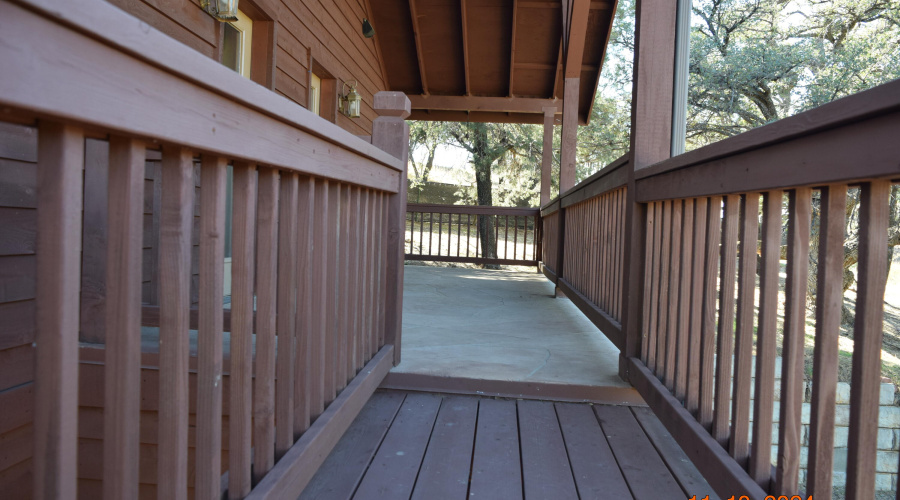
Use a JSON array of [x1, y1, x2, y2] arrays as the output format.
[[393, 265, 630, 387]]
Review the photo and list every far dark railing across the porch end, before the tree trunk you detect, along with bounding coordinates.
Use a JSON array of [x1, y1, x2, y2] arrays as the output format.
[[406, 203, 542, 266]]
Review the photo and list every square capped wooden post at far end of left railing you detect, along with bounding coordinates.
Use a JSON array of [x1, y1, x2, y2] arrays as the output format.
[[372, 92, 411, 366]]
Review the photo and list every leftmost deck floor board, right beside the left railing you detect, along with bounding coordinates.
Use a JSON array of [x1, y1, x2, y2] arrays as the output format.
[[300, 392, 405, 500]]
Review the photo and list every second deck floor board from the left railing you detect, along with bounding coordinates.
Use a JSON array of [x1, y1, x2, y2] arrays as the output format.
[[354, 394, 441, 500]]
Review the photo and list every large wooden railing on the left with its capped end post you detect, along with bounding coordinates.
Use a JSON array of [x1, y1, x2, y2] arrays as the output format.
[[0, 0, 409, 499]]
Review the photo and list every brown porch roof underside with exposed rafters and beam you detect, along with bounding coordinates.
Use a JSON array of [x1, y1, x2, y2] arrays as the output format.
[[368, 0, 616, 125]]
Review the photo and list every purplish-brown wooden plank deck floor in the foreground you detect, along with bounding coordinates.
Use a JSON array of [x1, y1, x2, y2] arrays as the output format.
[[300, 391, 714, 500]]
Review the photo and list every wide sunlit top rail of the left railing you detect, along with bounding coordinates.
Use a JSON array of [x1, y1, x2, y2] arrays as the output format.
[[0, 0, 404, 192]]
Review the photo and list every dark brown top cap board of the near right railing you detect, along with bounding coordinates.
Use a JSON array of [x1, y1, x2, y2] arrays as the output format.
[[635, 80, 900, 184]]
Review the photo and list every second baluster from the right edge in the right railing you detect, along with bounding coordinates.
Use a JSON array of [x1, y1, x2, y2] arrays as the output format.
[[806, 185, 847, 498]]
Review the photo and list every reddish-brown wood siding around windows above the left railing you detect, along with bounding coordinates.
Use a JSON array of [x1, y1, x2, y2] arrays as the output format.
[[105, 0, 387, 134]]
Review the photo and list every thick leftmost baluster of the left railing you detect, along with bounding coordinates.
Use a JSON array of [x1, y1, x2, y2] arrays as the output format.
[[33, 121, 84, 499]]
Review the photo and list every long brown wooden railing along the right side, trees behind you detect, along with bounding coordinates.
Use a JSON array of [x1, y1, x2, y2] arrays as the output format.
[[543, 81, 900, 499]]
